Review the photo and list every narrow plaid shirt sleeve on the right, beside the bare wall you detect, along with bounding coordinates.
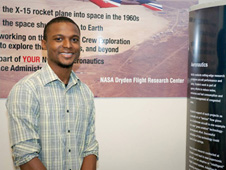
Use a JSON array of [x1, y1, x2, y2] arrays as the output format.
[[83, 98, 99, 159]]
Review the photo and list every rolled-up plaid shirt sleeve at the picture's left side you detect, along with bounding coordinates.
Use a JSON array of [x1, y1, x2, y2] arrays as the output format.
[[6, 84, 40, 166]]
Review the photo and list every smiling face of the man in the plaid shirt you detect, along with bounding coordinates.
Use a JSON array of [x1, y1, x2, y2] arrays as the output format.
[[42, 22, 80, 69]]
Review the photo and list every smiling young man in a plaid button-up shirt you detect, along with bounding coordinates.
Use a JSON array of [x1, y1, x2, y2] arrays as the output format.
[[6, 17, 98, 170]]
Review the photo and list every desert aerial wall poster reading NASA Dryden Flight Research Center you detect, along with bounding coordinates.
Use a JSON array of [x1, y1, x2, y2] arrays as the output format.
[[0, 0, 197, 98]]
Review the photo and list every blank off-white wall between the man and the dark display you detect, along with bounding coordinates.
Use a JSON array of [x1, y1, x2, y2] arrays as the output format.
[[96, 98, 186, 170]]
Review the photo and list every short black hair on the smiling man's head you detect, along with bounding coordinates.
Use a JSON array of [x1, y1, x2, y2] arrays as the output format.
[[43, 17, 80, 41]]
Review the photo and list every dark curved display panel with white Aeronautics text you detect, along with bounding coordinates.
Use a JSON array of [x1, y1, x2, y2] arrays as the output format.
[[186, 6, 226, 170]]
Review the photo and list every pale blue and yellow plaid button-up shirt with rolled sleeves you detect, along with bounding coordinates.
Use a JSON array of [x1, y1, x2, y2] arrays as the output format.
[[6, 64, 98, 170]]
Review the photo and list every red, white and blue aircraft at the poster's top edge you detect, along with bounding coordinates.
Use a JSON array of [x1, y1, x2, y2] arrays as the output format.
[[90, 0, 162, 11]]
